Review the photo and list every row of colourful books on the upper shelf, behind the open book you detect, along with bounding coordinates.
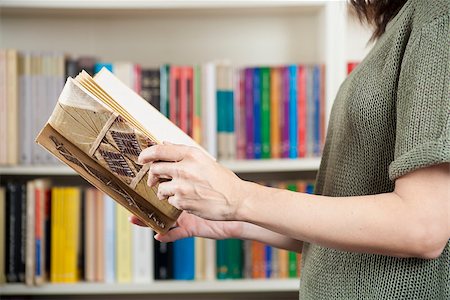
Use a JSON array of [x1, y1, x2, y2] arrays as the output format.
[[0, 49, 325, 165]]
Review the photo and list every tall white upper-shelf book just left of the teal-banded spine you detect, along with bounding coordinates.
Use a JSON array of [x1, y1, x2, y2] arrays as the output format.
[[202, 62, 217, 157]]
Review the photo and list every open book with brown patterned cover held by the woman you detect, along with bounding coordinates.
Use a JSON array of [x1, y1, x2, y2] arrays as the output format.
[[36, 68, 208, 233]]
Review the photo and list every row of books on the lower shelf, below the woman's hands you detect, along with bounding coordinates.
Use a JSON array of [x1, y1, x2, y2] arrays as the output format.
[[0, 179, 313, 285]]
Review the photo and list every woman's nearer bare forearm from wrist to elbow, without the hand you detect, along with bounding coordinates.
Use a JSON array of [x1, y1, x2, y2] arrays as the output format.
[[237, 165, 449, 258]]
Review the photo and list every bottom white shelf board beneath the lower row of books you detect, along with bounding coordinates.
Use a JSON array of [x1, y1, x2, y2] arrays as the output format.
[[0, 279, 300, 295]]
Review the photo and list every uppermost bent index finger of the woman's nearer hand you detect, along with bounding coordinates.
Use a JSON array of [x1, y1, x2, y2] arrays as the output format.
[[138, 144, 191, 164]]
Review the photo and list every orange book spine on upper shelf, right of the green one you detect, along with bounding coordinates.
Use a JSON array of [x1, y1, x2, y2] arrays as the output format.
[[270, 67, 281, 158]]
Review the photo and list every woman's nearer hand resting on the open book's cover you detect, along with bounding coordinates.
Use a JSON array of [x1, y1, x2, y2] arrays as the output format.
[[139, 143, 248, 221]]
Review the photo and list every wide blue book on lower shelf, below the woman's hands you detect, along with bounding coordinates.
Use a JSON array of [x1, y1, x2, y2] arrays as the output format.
[[173, 237, 195, 280]]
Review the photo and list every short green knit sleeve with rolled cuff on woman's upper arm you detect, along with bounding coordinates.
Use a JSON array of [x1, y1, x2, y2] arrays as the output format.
[[389, 14, 450, 180]]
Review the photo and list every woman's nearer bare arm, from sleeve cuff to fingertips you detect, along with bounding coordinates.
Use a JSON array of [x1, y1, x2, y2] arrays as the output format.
[[140, 145, 450, 258]]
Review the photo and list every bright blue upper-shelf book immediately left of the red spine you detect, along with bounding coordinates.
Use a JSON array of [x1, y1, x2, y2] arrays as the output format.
[[288, 65, 298, 158]]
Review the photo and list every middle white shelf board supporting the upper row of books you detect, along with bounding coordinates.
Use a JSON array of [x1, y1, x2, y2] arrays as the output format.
[[0, 158, 320, 176]]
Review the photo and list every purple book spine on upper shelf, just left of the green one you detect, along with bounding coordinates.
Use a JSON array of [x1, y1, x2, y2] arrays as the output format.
[[245, 68, 255, 159]]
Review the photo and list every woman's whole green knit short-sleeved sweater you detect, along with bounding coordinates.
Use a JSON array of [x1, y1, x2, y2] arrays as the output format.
[[300, 0, 450, 300]]
